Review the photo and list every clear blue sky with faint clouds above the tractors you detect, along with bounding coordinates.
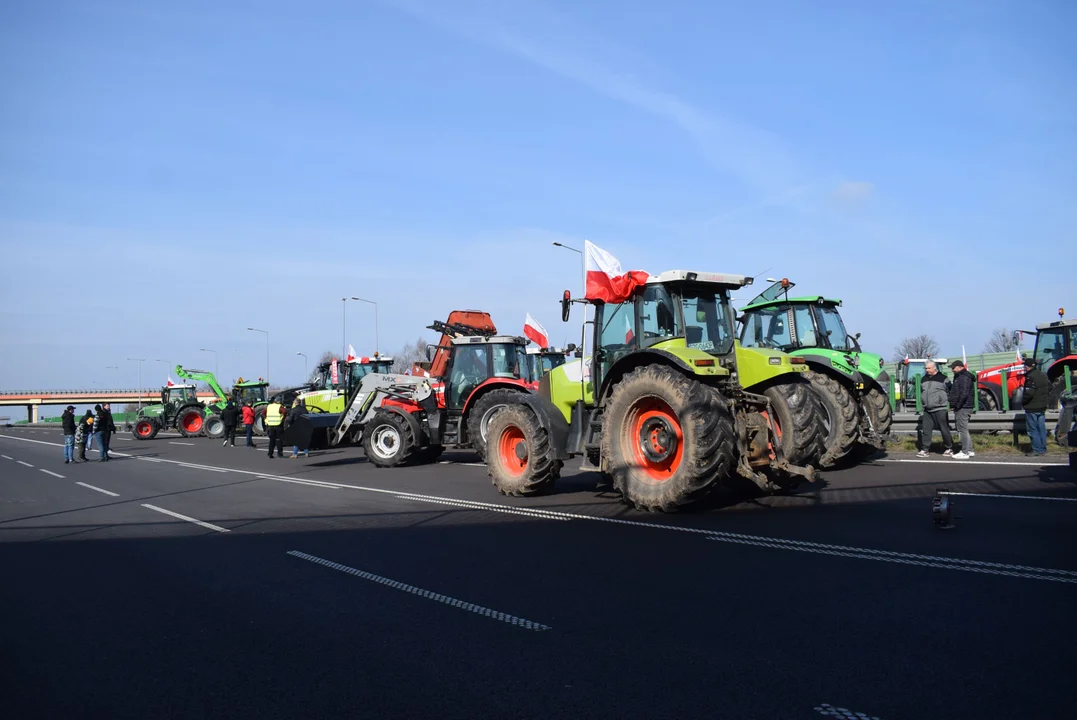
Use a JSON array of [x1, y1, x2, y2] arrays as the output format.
[[0, 0, 1077, 390]]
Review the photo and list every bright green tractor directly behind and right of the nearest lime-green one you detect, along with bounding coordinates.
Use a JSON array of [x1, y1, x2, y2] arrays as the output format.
[[740, 278, 893, 467]]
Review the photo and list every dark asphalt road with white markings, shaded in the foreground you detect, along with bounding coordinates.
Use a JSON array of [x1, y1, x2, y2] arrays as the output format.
[[0, 429, 1077, 720]]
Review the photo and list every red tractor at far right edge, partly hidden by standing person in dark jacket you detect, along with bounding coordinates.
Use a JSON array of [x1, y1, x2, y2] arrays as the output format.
[[976, 308, 1077, 410]]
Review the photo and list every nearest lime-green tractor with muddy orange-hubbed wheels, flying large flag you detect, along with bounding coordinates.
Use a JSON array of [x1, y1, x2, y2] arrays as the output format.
[[487, 270, 823, 511]]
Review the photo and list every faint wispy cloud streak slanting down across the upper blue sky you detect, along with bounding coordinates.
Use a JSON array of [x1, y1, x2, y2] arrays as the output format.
[[389, 0, 797, 196]]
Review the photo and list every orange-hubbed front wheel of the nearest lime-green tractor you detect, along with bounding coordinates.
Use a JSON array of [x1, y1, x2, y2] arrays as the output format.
[[486, 404, 562, 495]]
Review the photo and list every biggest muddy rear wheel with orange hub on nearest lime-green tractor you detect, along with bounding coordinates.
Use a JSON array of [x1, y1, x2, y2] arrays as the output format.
[[602, 365, 735, 512]]
